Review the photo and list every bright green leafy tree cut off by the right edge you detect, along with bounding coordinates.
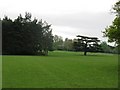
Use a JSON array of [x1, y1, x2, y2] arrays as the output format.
[[103, 0, 120, 46]]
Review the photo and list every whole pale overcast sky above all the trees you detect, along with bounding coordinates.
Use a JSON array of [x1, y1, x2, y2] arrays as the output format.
[[0, 0, 117, 45]]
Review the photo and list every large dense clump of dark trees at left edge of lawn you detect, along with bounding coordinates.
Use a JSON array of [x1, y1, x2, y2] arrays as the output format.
[[2, 13, 53, 55]]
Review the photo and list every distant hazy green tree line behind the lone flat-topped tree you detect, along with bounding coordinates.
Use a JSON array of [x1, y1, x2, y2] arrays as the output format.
[[53, 35, 118, 54]]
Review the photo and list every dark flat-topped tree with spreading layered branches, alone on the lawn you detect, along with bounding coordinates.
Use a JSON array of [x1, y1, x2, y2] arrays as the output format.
[[73, 35, 101, 55]]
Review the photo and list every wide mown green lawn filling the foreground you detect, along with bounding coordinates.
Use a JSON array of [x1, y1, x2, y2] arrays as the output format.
[[2, 51, 118, 88]]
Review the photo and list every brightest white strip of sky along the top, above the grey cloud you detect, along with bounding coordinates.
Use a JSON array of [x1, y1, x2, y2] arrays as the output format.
[[0, 0, 117, 14]]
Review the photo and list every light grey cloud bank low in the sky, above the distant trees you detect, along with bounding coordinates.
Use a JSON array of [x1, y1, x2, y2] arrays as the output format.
[[36, 12, 114, 39]]
